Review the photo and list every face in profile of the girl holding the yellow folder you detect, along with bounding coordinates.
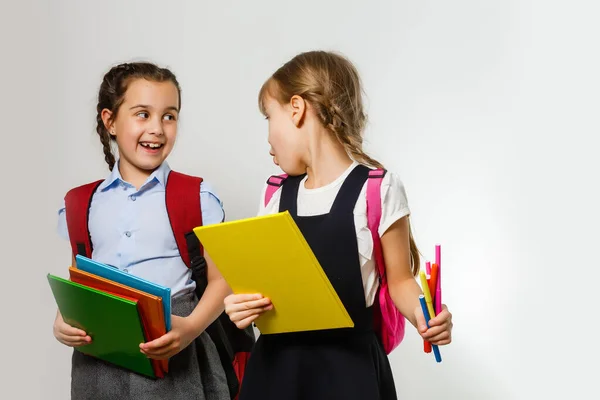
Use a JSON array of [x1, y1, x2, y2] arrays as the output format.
[[264, 96, 307, 176]]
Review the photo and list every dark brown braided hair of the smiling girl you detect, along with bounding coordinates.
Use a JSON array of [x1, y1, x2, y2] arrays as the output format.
[[96, 62, 181, 171]]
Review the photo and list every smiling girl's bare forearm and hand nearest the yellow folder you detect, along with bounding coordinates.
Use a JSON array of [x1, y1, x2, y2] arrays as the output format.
[[140, 254, 231, 360]]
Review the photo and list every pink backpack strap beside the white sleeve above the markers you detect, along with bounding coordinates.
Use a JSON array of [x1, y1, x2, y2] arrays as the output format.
[[367, 169, 387, 280]]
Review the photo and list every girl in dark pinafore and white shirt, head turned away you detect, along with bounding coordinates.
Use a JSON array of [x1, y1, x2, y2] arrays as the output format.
[[225, 51, 452, 400]]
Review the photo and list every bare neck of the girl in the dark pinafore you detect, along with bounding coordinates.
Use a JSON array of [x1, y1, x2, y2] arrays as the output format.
[[304, 130, 352, 189]]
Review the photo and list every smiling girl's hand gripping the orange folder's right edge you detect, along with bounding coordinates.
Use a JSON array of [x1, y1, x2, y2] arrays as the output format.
[[140, 315, 198, 360]]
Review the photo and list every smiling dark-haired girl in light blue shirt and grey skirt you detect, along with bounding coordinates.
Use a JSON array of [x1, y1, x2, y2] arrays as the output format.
[[54, 63, 230, 400]]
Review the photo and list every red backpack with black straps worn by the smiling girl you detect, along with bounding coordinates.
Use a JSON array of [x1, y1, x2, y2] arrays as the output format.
[[65, 171, 255, 399]]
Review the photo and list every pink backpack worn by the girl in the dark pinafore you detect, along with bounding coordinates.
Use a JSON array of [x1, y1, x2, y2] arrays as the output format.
[[265, 169, 406, 354]]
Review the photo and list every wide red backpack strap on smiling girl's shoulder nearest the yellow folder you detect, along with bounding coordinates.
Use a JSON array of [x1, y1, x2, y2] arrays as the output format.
[[165, 171, 202, 268]]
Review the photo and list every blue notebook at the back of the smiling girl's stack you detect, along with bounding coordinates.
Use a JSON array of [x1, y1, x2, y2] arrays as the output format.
[[75, 255, 171, 332]]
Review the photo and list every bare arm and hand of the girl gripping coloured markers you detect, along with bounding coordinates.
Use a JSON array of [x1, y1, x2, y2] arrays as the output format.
[[381, 216, 452, 345]]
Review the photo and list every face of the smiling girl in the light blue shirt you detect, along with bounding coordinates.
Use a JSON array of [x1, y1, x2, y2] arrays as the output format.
[[103, 79, 179, 173]]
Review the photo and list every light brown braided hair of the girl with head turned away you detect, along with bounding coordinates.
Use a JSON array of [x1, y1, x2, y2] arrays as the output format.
[[258, 51, 420, 276]]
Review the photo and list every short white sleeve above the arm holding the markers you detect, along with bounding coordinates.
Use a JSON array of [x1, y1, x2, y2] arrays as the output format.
[[379, 172, 410, 236]]
